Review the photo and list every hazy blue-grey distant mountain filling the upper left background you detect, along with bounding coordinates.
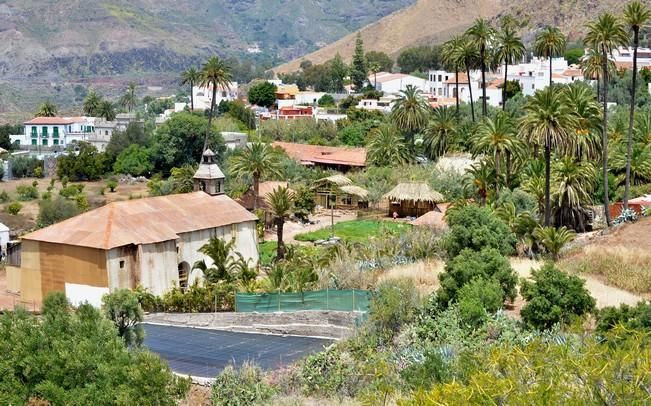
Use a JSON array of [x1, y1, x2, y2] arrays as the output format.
[[0, 0, 414, 117]]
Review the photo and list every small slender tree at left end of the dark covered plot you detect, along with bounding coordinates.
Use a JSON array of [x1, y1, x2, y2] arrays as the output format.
[[102, 289, 145, 347]]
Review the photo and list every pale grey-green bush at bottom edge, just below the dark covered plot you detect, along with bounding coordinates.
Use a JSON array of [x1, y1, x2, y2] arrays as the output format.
[[210, 363, 276, 406]]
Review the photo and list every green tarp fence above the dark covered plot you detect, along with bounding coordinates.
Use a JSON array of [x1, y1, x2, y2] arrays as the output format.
[[235, 290, 371, 313]]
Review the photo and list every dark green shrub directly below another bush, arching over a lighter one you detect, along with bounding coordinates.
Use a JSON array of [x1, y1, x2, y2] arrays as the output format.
[[437, 248, 518, 307]]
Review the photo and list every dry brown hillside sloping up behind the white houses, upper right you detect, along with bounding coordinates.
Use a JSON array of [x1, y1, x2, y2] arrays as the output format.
[[274, 0, 623, 73]]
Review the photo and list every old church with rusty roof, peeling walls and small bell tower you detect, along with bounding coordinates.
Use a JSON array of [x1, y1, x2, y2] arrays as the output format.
[[7, 149, 258, 306]]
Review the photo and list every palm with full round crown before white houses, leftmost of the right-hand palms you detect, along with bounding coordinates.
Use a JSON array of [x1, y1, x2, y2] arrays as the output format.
[[391, 85, 431, 147]]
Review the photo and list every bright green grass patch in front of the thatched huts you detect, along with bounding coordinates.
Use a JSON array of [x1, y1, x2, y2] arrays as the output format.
[[294, 220, 411, 242]]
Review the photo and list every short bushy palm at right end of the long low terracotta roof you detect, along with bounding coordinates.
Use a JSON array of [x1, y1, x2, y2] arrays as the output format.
[[366, 125, 409, 166]]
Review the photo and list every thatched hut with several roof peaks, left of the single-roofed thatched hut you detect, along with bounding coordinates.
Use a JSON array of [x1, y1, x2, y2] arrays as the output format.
[[315, 175, 368, 210]]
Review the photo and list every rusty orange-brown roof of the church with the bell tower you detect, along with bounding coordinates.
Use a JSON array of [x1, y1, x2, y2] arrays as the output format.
[[23, 192, 257, 250]]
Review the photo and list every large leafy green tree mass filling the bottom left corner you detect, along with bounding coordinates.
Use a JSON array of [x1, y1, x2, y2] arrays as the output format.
[[0, 293, 190, 406]]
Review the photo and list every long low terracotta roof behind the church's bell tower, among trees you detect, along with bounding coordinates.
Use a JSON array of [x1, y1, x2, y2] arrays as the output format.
[[272, 141, 366, 167]]
